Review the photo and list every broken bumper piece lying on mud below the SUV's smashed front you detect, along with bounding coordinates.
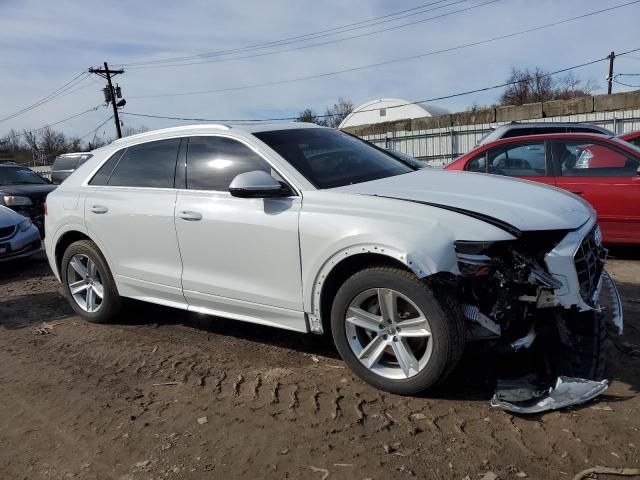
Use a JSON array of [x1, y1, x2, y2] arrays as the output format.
[[491, 377, 609, 413]]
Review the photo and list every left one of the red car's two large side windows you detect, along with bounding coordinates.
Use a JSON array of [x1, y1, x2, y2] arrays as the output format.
[[487, 142, 546, 177]]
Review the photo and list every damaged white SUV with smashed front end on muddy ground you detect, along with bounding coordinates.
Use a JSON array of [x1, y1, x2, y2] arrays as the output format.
[[45, 123, 622, 409]]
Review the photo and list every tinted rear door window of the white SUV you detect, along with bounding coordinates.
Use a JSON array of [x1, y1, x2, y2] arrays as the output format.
[[107, 138, 180, 188]]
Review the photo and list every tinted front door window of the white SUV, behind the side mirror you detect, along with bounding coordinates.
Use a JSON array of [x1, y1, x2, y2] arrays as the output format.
[[187, 137, 278, 191]]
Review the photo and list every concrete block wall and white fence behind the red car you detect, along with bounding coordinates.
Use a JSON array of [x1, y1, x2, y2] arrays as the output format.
[[344, 90, 640, 165]]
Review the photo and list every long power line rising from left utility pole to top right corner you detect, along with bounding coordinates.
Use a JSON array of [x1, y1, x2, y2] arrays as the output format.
[[130, 0, 640, 99]]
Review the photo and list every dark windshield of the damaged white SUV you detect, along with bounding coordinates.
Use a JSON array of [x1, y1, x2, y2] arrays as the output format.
[[254, 128, 415, 189]]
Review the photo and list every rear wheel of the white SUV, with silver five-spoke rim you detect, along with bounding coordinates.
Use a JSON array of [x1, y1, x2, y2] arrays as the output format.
[[60, 240, 121, 323]]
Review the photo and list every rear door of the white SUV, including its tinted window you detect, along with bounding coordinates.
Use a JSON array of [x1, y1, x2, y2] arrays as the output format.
[[85, 138, 186, 307]]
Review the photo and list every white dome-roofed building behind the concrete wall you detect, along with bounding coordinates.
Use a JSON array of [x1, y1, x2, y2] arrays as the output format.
[[339, 98, 449, 128]]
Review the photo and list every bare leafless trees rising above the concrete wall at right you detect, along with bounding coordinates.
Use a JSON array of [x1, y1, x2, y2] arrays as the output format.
[[500, 67, 598, 105]]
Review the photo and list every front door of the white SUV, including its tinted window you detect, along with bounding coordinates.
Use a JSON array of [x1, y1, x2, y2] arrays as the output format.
[[175, 136, 305, 331]]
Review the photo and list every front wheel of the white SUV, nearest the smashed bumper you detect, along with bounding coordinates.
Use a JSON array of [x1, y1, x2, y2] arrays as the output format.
[[331, 267, 465, 395]]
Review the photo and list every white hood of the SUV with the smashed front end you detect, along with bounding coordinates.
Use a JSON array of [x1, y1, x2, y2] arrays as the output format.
[[332, 169, 595, 231]]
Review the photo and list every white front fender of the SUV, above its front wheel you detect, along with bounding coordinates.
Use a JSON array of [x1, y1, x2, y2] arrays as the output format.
[[300, 190, 513, 317]]
